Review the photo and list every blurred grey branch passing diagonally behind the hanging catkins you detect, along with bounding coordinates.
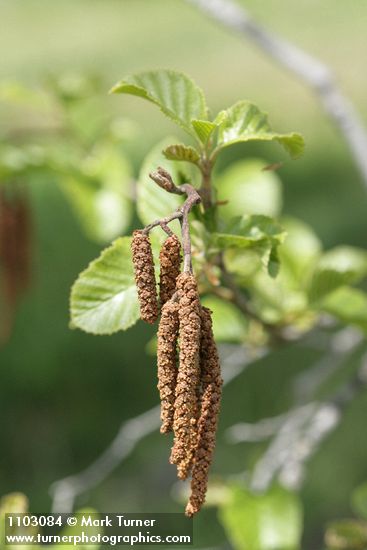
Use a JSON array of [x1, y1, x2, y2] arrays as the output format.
[[50, 345, 267, 513]]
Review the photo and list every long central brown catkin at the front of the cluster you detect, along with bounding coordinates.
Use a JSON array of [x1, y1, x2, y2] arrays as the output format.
[[170, 273, 201, 479]]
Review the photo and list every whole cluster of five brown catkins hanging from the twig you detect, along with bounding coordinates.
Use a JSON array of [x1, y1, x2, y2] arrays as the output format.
[[132, 231, 222, 516]]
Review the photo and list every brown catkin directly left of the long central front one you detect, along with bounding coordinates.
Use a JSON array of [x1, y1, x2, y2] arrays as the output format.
[[157, 302, 179, 434]]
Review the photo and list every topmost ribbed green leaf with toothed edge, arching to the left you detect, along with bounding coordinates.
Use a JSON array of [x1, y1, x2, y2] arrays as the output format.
[[111, 69, 208, 137]]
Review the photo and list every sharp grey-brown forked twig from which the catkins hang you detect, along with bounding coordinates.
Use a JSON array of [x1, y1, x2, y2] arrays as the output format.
[[143, 167, 201, 273]]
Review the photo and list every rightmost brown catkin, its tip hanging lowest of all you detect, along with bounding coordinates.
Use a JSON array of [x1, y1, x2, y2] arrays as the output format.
[[185, 307, 223, 516]]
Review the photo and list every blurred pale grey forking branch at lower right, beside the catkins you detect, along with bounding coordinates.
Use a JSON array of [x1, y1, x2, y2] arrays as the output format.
[[226, 327, 367, 491]]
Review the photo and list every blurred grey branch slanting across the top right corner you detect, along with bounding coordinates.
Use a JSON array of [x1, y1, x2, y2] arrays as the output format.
[[186, 0, 367, 187]]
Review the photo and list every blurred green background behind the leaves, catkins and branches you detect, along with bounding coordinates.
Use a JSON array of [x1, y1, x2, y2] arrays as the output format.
[[0, 0, 367, 548]]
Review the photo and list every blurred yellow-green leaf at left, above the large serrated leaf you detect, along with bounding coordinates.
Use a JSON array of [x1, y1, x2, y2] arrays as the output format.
[[59, 146, 133, 243]]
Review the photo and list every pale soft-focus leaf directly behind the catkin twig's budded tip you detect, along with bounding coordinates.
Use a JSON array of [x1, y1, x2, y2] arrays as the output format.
[[137, 138, 183, 231]]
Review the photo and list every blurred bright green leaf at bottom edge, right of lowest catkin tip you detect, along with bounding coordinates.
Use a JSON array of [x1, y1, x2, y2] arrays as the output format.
[[219, 485, 302, 550]]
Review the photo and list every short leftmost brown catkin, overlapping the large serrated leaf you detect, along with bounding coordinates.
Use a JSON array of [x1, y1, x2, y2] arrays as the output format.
[[131, 231, 159, 323]]
